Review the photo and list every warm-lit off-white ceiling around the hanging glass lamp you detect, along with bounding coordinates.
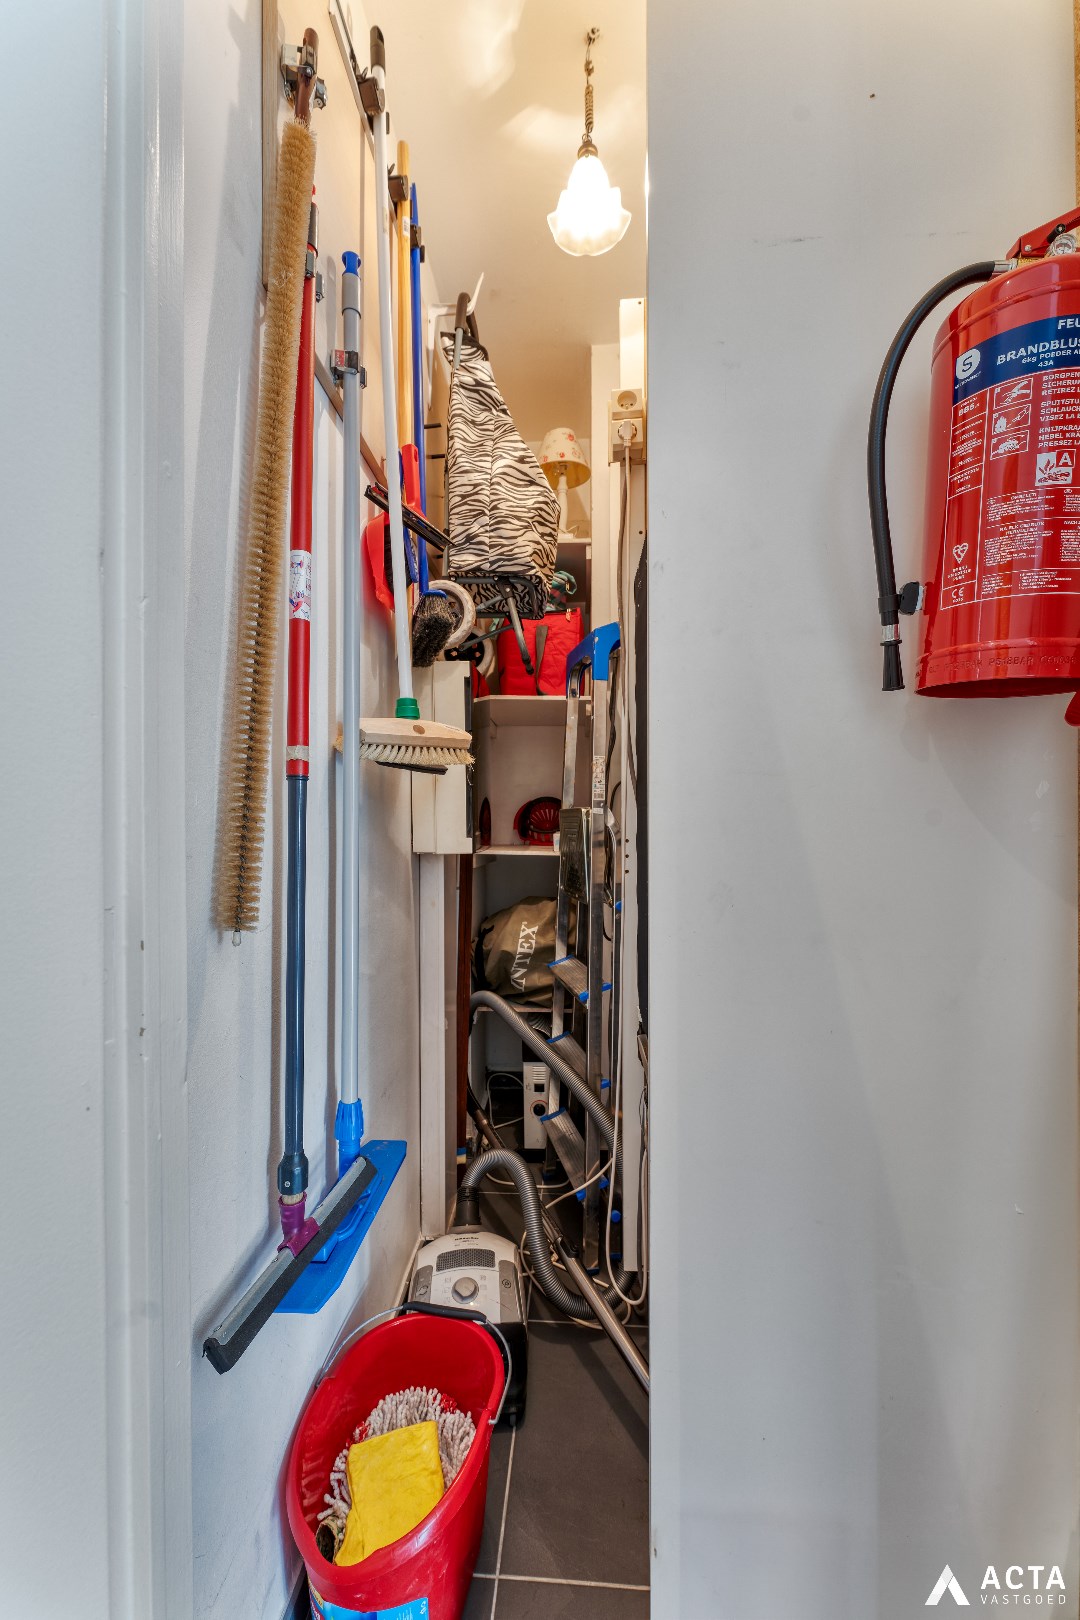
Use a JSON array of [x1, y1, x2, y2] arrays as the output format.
[[383, 0, 646, 439]]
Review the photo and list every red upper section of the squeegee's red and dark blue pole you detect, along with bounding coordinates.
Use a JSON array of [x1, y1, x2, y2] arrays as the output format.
[[285, 203, 317, 776]]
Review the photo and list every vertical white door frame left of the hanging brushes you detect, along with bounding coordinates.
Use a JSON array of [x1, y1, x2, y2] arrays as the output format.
[[102, 0, 193, 1620]]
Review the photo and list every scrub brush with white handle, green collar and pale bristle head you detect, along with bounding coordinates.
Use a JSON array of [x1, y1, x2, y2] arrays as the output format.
[[359, 28, 473, 776]]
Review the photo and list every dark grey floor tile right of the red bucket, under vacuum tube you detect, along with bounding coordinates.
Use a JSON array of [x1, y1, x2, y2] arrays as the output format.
[[499, 1322, 649, 1581]]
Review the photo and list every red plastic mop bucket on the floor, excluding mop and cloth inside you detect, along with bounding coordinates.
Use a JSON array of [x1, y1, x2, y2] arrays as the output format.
[[285, 1306, 505, 1620]]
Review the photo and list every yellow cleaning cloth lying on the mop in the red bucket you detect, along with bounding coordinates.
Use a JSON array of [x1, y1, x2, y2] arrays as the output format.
[[334, 1422, 445, 1563]]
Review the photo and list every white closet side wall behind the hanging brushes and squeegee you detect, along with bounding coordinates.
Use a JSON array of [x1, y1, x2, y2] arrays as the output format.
[[185, 0, 419, 1620]]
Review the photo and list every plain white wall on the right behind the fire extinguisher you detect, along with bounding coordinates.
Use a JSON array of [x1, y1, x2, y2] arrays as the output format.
[[649, 0, 1078, 1620]]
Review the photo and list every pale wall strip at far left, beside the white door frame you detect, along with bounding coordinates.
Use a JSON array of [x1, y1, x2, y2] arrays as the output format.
[[0, 5, 108, 1617]]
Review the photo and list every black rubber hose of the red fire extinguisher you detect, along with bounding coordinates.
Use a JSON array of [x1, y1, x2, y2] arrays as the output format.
[[866, 261, 1009, 692]]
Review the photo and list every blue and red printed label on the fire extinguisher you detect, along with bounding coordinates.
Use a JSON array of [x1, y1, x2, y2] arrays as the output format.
[[938, 316, 1080, 611]]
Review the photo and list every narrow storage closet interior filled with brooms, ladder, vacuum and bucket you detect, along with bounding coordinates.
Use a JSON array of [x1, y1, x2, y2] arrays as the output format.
[[196, 0, 649, 1620]]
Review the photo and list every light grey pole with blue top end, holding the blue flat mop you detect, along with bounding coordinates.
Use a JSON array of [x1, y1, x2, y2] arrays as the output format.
[[338, 271, 359, 1103]]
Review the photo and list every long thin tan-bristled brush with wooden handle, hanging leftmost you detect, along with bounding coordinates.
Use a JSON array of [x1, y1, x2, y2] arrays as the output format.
[[214, 29, 319, 944]]
